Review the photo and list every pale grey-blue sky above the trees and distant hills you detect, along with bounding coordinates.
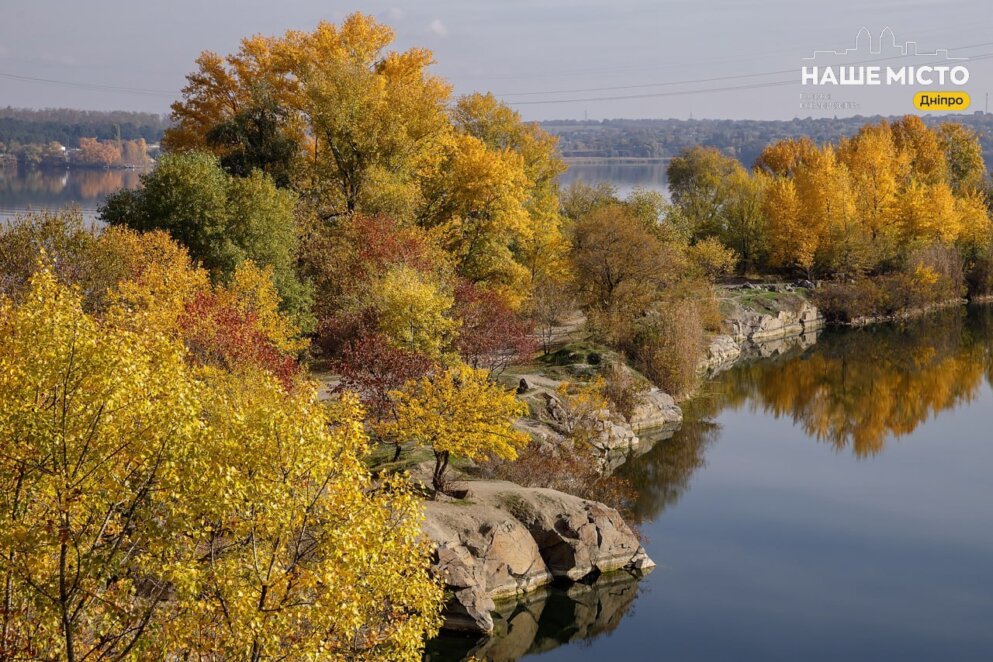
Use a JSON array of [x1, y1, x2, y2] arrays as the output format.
[[0, 0, 993, 120]]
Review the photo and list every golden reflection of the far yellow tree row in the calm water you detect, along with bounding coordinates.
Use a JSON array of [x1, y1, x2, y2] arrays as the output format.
[[711, 307, 991, 457]]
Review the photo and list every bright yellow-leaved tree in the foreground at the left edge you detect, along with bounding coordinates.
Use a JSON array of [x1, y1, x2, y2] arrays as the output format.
[[0, 270, 199, 661]]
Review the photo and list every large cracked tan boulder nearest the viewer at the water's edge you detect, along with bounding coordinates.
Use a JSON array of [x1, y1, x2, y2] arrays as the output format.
[[424, 481, 654, 632]]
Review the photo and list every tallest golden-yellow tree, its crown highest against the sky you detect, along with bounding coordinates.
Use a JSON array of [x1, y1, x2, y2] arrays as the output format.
[[294, 14, 451, 218]]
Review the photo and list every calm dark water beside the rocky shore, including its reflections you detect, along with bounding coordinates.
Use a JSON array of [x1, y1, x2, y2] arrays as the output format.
[[436, 306, 993, 661]]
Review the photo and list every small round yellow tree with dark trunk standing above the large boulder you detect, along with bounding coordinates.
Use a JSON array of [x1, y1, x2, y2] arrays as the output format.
[[392, 364, 530, 491]]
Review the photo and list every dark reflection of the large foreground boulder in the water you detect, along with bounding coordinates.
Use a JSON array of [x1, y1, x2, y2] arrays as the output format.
[[425, 572, 638, 662]]
